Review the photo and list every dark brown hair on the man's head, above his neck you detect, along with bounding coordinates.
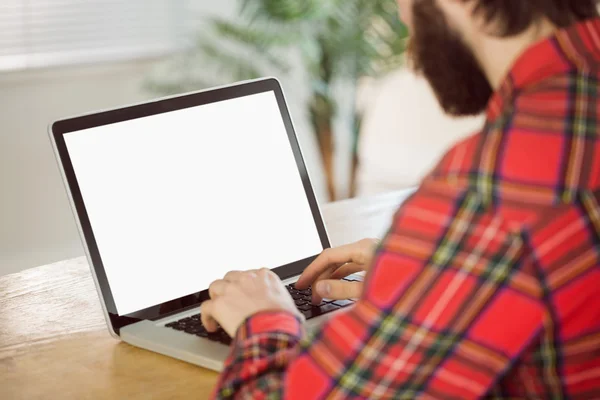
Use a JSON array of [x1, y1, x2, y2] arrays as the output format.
[[469, 0, 600, 37]]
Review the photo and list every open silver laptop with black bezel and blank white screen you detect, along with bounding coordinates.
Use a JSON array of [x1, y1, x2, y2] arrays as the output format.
[[49, 78, 360, 371]]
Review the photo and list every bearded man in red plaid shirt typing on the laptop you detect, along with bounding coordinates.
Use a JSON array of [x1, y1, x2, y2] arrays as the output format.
[[202, 0, 600, 399]]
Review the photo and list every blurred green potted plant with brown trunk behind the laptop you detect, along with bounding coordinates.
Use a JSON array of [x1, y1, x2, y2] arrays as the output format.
[[150, 0, 407, 200]]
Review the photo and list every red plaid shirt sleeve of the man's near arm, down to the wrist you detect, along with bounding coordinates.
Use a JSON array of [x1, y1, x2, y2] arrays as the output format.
[[214, 183, 545, 399]]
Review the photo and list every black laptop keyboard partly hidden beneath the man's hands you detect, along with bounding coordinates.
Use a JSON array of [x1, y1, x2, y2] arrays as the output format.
[[165, 275, 362, 345]]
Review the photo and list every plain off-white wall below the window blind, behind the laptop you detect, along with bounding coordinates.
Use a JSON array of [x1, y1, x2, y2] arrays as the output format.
[[0, 0, 324, 276]]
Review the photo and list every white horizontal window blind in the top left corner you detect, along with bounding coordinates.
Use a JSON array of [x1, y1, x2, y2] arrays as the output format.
[[0, 0, 186, 70]]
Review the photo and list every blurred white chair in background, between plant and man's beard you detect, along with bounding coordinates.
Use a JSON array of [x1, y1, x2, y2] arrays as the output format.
[[356, 69, 484, 196]]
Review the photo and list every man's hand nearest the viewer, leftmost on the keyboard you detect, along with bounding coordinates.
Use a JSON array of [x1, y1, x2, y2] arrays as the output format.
[[200, 268, 304, 337]]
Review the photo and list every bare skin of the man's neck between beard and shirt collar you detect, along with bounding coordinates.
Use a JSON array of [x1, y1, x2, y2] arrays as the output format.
[[473, 21, 556, 89]]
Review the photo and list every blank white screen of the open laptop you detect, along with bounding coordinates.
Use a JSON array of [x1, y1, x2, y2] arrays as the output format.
[[64, 91, 323, 315]]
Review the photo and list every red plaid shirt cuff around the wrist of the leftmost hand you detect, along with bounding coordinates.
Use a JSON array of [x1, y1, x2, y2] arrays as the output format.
[[235, 310, 304, 341]]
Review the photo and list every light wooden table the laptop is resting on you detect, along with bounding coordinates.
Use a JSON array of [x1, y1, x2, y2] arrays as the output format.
[[0, 191, 410, 399]]
